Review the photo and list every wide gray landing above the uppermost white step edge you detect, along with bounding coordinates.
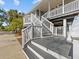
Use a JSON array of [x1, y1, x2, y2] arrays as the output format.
[[33, 38, 72, 59]]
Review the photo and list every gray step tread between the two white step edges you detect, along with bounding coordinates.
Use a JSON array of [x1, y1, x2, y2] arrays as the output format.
[[29, 44, 56, 59]]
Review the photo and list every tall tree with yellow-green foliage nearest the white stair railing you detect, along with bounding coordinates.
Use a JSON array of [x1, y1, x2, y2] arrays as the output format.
[[7, 10, 23, 32]]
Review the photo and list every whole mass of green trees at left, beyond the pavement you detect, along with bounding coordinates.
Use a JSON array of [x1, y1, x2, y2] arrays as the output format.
[[0, 9, 23, 31]]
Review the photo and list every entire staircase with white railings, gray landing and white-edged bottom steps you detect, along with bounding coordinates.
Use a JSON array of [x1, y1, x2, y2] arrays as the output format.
[[22, 14, 72, 59]]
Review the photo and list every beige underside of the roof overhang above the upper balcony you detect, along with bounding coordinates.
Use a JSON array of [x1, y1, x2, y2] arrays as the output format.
[[26, 0, 74, 13]]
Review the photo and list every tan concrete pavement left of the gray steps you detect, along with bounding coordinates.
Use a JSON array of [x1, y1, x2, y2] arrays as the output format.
[[0, 34, 26, 59]]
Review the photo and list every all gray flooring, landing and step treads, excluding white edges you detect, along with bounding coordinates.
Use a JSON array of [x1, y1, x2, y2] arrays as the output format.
[[24, 37, 72, 59]]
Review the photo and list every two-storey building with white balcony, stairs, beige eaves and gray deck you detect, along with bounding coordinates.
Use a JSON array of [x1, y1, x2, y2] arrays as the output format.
[[22, 0, 79, 59]]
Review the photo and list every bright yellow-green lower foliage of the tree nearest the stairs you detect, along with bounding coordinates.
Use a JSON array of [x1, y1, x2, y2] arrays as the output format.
[[8, 18, 22, 31]]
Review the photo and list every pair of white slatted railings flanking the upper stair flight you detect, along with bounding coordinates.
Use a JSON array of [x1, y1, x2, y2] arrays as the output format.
[[32, 14, 53, 37]]
